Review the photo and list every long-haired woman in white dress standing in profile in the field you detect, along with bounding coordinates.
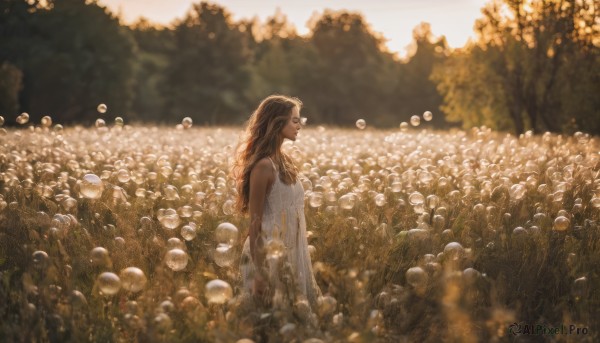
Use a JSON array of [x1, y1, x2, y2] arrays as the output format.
[[234, 95, 321, 308]]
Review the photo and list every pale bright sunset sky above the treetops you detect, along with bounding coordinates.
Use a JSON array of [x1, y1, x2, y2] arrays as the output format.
[[98, 0, 489, 56]]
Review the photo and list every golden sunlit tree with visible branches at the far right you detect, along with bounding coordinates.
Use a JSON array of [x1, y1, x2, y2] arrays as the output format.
[[436, 0, 600, 134]]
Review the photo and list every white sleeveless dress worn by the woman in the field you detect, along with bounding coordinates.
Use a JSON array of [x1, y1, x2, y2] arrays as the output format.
[[240, 160, 321, 309]]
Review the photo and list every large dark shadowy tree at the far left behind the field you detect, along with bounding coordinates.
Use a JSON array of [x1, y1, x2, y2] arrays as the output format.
[[2, 0, 135, 122]]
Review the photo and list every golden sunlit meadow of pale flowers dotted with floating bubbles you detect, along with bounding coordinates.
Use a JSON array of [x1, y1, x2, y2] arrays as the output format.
[[0, 119, 600, 343]]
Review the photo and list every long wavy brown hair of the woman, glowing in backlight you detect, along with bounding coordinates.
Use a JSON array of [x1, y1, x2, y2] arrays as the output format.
[[232, 95, 302, 213]]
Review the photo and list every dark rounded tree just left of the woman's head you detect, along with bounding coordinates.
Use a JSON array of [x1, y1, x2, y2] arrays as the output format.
[[163, 2, 250, 124]]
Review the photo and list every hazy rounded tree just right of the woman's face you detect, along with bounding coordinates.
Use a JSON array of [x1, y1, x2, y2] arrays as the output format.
[[301, 11, 394, 125]]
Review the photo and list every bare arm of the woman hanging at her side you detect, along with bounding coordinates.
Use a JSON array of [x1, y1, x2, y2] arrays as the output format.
[[248, 158, 274, 273]]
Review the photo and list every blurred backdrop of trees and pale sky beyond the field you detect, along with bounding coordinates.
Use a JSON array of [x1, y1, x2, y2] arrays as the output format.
[[0, 0, 600, 134]]
